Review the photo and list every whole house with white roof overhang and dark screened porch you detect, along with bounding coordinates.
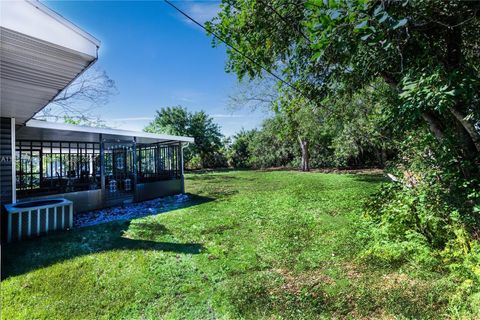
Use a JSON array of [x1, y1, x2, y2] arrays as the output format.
[[0, 0, 193, 238]]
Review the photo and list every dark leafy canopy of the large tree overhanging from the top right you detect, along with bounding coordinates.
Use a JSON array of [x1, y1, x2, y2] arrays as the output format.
[[209, 0, 480, 177]]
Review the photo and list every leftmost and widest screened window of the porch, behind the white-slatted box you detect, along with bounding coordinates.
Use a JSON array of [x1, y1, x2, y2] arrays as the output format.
[[16, 140, 100, 198]]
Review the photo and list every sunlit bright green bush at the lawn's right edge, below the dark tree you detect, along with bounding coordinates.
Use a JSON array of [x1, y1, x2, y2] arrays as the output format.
[[360, 181, 480, 316]]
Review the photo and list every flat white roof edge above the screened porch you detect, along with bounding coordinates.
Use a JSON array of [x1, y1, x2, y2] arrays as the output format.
[[16, 120, 194, 143]]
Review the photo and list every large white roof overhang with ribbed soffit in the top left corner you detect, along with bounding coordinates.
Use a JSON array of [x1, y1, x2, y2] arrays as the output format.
[[0, 1, 100, 124]]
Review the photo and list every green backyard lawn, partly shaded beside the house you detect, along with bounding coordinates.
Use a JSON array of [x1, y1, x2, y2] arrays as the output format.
[[1, 171, 449, 319]]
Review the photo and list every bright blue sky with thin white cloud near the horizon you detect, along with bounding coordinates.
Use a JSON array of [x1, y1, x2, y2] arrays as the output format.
[[44, 1, 267, 136]]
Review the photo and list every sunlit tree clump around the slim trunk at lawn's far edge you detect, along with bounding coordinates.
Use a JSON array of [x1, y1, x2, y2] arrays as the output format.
[[227, 81, 396, 168]]
